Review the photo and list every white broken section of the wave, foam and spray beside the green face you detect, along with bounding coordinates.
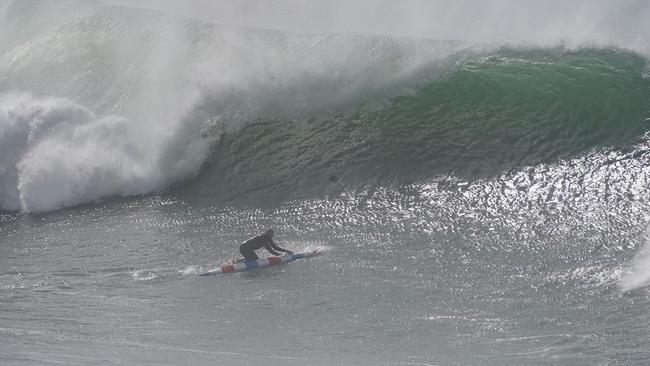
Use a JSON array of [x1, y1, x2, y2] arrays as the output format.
[[0, 0, 463, 212]]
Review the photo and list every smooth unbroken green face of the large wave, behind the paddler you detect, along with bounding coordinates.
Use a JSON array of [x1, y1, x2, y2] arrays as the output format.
[[182, 49, 650, 204]]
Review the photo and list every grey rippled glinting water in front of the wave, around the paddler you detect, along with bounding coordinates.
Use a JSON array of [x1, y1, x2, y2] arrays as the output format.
[[0, 156, 650, 365]]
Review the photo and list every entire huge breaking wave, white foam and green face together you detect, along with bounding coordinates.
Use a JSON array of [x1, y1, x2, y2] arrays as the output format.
[[0, 0, 650, 212]]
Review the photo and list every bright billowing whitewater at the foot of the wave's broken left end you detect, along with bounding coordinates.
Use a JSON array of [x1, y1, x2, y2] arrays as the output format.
[[0, 94, 205, 212]]
